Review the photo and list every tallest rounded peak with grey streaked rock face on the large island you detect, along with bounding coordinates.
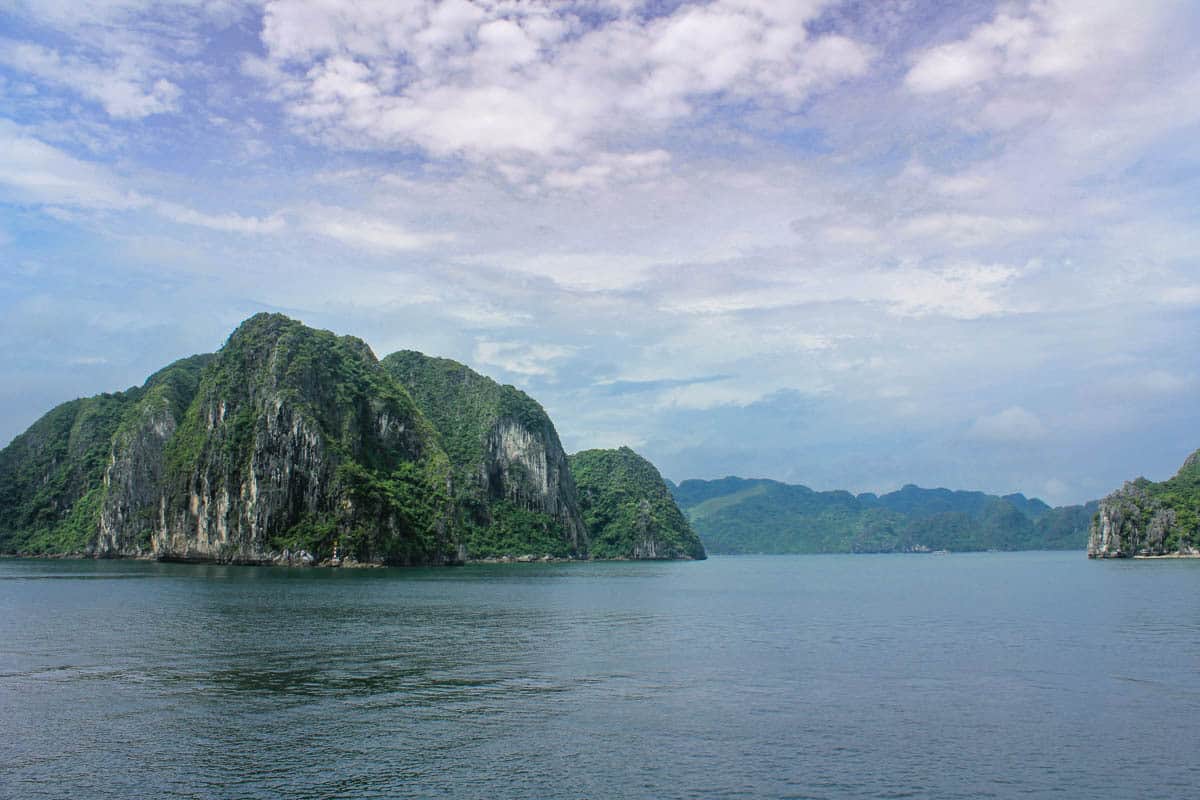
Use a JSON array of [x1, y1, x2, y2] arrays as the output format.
[[146, 314, 457, 564]]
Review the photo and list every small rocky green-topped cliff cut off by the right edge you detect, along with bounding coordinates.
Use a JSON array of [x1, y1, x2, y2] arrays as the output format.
[[1087, 451, 1200, 558]]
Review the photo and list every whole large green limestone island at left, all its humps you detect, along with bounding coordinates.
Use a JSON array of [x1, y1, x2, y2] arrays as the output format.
[[0, 314, 706, 566]]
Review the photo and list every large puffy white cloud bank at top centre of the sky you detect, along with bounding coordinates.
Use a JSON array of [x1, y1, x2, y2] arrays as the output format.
[[247, 0, 872, 178]]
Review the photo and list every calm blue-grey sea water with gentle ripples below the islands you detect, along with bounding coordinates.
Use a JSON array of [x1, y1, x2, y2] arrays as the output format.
[[0, 553, 1200, 800]]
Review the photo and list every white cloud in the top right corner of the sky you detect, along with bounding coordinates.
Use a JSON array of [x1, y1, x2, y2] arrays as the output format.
[[905, 0, 1200, 181]]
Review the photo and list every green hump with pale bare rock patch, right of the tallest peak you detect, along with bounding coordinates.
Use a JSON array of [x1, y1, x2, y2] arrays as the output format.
[[383, 350, 588, 558]]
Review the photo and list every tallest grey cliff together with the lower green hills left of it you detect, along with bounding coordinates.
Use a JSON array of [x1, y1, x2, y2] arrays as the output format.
[[0, 314, 461, 564]]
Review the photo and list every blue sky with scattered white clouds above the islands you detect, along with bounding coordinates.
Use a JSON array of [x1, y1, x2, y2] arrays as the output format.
[[0, 0, 1200, 504]]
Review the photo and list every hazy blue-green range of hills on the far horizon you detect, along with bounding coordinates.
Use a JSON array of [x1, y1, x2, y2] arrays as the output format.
[[672, 477, 1099, 554]]
